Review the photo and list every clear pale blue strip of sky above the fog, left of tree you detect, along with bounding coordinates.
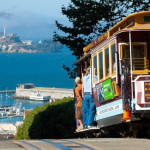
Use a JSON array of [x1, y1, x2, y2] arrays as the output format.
[[0, 0, 69, 17]]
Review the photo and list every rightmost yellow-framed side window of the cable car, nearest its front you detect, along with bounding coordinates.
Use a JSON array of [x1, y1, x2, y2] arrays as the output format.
[[111, 44, 116, 73]]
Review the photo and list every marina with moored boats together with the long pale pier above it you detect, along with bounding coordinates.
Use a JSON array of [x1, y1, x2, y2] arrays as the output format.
[[0, 83, 74, 122]]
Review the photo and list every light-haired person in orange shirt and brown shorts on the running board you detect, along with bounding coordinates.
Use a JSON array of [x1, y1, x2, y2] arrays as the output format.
[[75, 77, 83, 131]]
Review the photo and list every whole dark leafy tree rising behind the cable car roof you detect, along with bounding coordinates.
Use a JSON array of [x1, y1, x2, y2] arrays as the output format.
[[53, 0, 150, 75]]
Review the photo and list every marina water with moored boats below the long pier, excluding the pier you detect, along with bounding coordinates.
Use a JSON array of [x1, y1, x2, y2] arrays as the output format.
[[0, 93, 49, 124]]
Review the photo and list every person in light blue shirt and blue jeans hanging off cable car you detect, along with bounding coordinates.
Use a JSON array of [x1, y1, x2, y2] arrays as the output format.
[[82, 67, 97, 129]]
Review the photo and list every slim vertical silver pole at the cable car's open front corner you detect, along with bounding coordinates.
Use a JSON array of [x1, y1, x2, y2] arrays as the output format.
[[129, 31, 133, 108]]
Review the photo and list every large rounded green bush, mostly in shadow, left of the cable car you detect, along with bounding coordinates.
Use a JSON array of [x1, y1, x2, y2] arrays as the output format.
[[15, 98, 75, 139]]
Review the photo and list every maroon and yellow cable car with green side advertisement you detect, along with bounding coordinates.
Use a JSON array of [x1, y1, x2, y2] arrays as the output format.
[[75, 11, 150, 137]]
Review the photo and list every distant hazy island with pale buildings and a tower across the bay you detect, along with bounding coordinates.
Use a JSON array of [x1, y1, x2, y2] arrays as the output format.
[[0, 27, 62, 53]]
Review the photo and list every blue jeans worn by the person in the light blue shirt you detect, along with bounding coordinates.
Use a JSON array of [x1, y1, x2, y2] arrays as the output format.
[[82, 94, 95, 126]]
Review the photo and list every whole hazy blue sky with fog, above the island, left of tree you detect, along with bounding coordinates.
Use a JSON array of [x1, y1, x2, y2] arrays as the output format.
[[0, 0, 70, 41]]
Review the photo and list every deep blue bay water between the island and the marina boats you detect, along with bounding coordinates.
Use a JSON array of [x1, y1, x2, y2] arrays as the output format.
[[0, 47, 75, 122]]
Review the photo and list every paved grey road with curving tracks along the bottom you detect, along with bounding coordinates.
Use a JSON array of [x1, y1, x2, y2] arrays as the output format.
[[0, 138, 150, 150]]
